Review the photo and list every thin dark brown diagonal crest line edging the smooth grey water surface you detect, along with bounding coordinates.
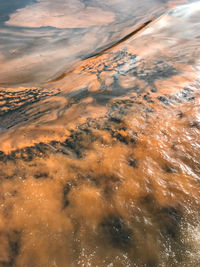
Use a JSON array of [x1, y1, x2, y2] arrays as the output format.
[[47, 17, 154, 83]]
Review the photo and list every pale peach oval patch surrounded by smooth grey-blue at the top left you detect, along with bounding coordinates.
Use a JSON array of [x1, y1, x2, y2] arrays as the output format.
[[6, 0, 115, 28]]
